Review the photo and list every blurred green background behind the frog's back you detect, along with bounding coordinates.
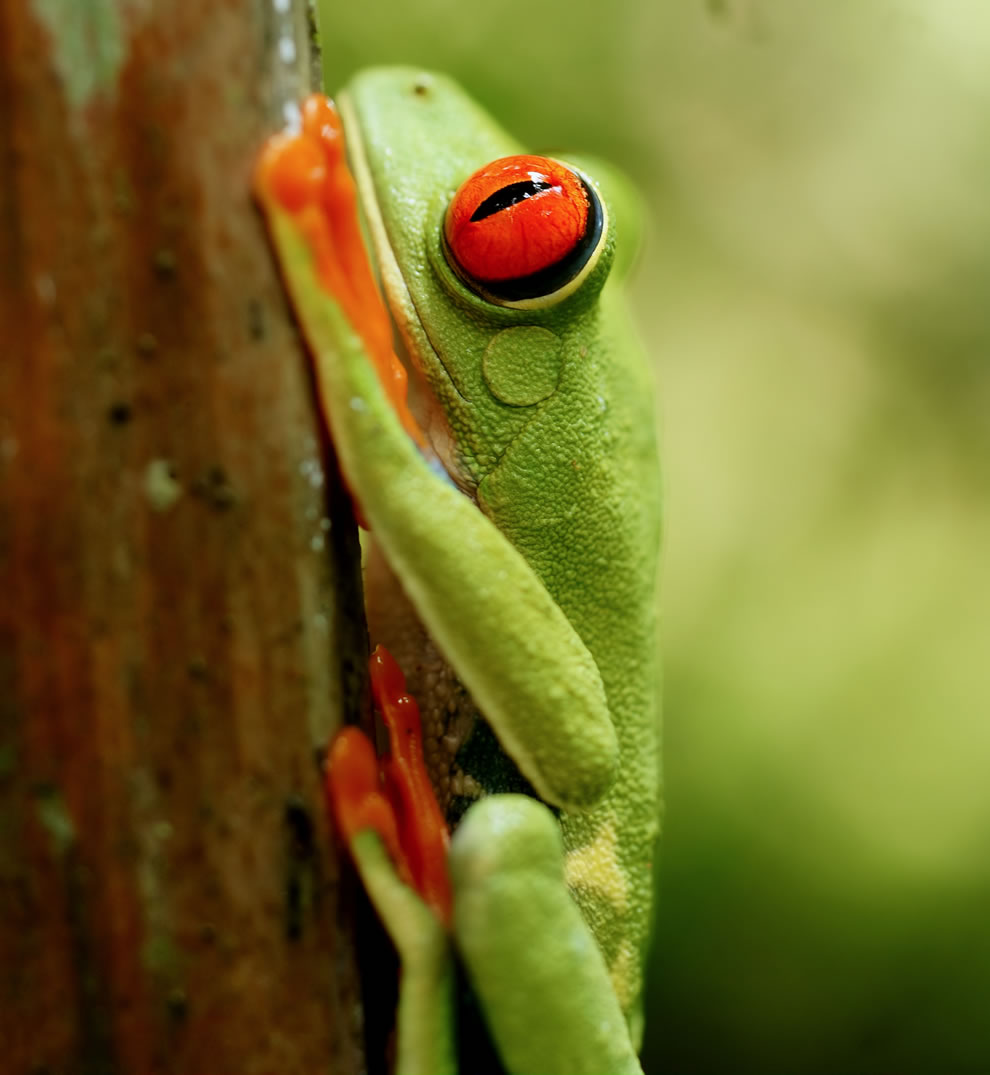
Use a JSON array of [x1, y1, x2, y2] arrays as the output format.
[[324, 0, 990, 1075]]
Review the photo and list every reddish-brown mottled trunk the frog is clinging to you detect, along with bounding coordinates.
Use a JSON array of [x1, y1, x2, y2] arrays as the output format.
[[0, 0, 360, 1075]]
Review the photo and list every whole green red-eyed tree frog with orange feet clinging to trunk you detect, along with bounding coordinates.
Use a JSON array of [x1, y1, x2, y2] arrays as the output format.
[[256, 69, 660, 1075]]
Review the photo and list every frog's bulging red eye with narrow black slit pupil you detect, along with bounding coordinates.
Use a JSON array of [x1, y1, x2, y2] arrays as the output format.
[[444, 156, 604, 305]]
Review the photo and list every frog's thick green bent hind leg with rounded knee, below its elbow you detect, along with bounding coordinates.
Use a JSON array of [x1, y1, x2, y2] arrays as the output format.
[[450, 796, 642, 1075]]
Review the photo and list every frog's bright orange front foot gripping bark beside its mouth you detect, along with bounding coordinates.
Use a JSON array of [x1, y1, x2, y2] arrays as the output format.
[[255, 94, 424, 447]]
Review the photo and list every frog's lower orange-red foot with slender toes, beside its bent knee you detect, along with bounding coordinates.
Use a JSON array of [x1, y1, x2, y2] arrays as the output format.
[[327, 646, 453, 925]]
